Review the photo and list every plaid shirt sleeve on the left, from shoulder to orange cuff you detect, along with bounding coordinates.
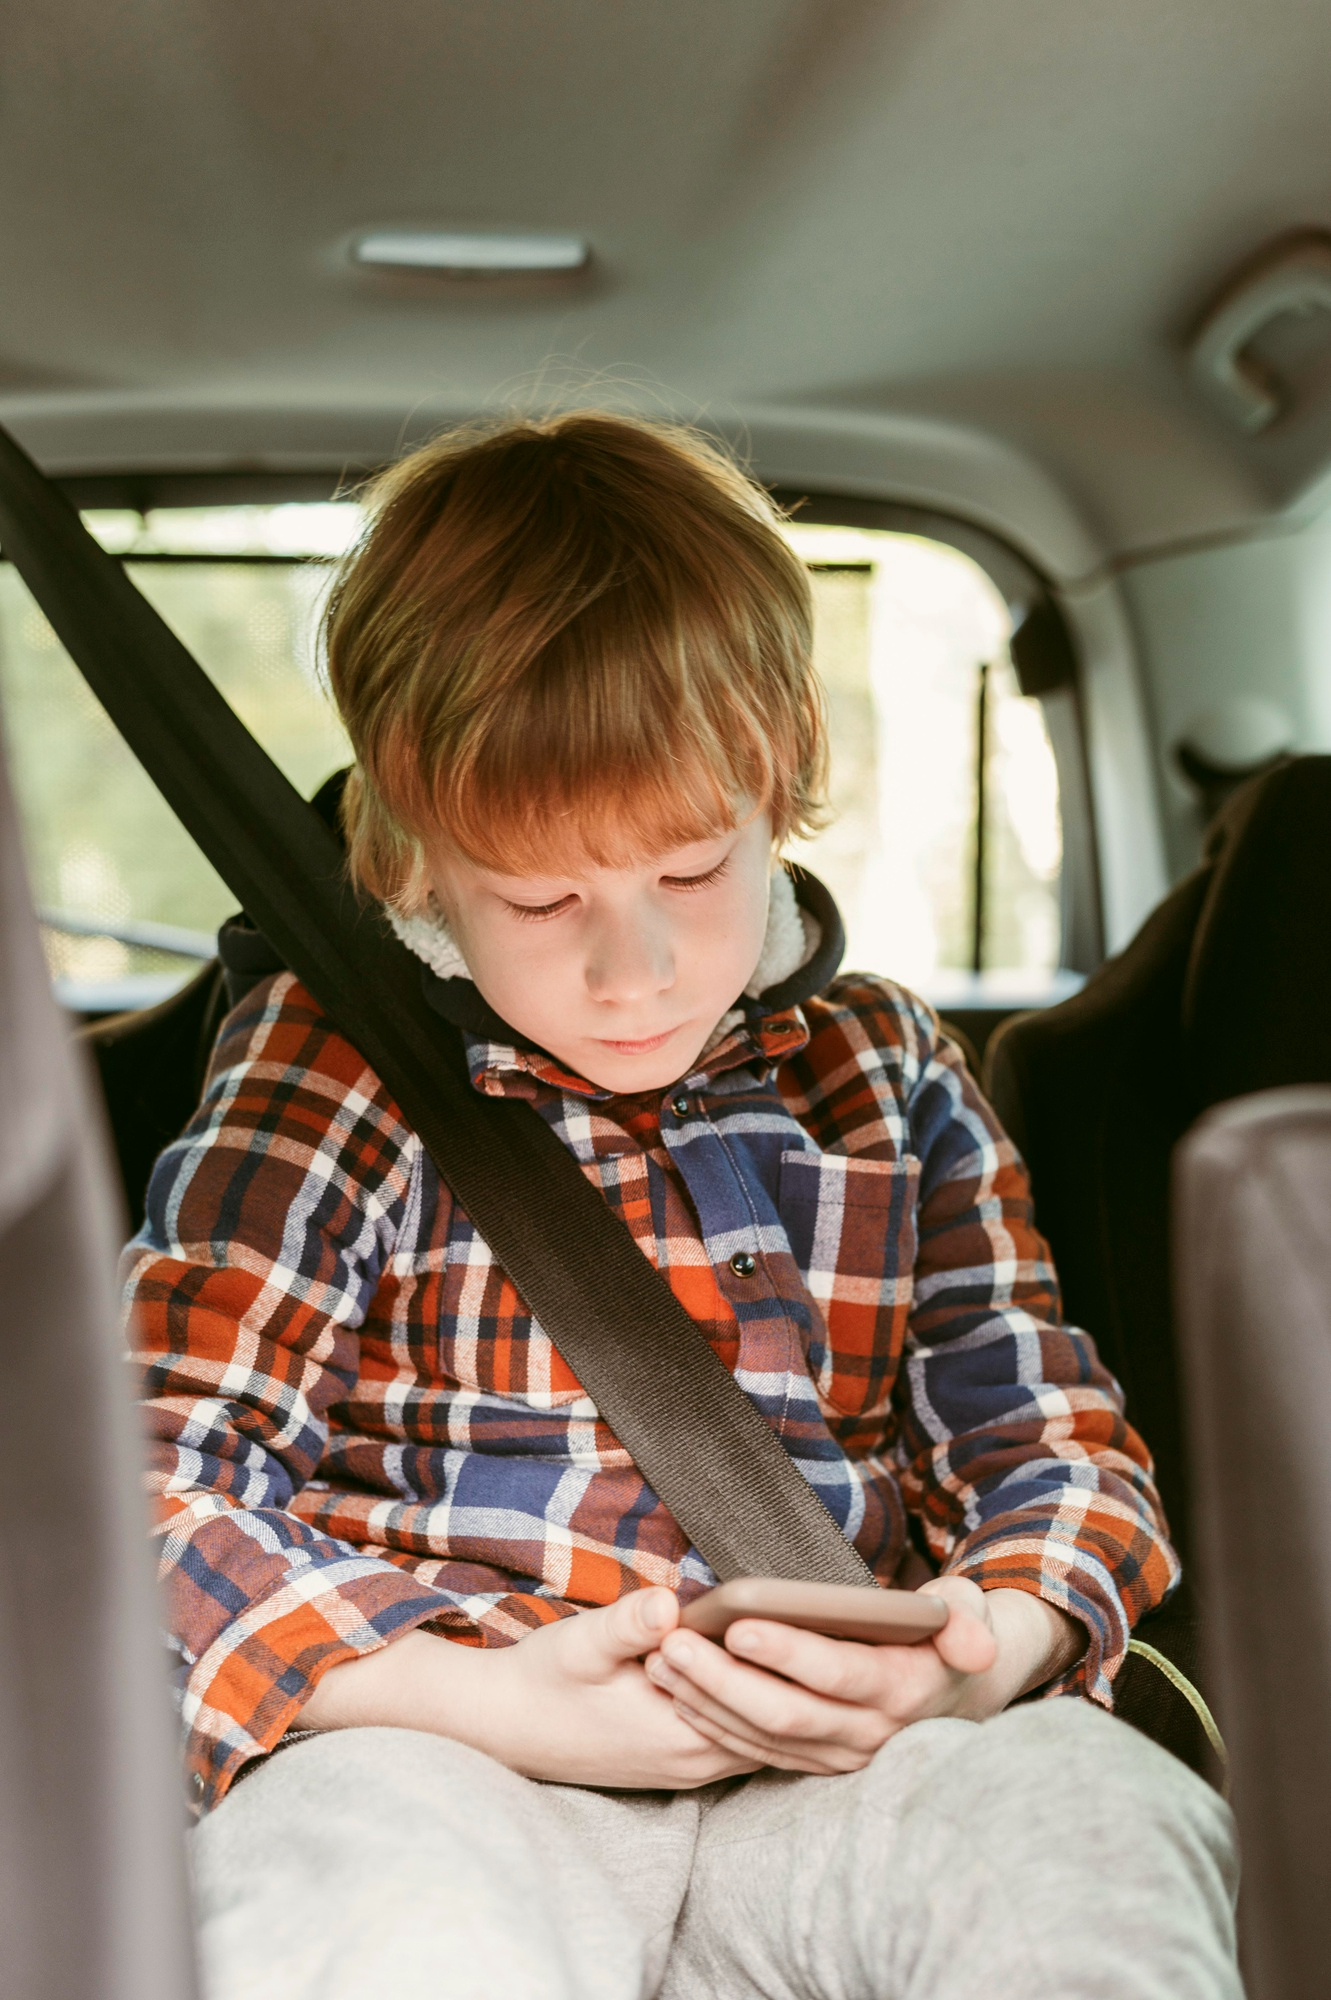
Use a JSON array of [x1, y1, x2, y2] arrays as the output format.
[[124, 976, 450, 1806]]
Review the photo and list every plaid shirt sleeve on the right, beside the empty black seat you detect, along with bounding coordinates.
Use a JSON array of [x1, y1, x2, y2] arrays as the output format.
[[897, 1002, 1179, 1706]]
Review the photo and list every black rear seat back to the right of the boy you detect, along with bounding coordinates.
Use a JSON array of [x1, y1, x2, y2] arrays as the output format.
[[987, 756, 1331, 1768]]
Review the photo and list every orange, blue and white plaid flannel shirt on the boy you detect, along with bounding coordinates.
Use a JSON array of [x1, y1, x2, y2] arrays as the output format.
[[126, 944, 1177, 1806]]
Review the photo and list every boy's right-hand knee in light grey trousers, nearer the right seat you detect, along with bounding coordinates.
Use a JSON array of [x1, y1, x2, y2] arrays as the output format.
[[843, 1698, 1239, 2000]]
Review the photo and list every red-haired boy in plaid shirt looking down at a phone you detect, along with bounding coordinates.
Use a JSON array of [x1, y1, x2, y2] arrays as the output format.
[[128, 414, 1239, 2000]]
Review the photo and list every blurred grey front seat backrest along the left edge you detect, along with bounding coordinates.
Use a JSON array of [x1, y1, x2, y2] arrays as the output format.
[[0, 744, 194, 2000]]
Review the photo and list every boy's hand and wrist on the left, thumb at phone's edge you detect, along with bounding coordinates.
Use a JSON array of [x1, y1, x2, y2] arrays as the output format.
[[300, 1590, 763, 1792]]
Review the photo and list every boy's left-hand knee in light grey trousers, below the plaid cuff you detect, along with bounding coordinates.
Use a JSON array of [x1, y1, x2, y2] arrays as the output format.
[[192, 1728, 642, 2000]]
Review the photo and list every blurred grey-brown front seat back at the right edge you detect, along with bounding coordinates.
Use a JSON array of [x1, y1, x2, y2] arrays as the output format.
[[1175, 1086, 1331, 2000]]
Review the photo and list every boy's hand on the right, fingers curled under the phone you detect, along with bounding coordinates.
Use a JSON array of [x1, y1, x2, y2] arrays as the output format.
[[648, 1576, 1085, 1774]]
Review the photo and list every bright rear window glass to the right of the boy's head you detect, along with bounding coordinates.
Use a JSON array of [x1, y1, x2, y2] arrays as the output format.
[[787, 522, 1061, 1004]]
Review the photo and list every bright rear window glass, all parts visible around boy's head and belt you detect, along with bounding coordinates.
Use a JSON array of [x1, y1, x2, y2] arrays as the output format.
[[0, 502, 1061, 1010]]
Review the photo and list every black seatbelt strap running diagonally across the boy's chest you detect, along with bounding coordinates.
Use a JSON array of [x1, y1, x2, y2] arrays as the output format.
[[0, 428, 875, 1584]]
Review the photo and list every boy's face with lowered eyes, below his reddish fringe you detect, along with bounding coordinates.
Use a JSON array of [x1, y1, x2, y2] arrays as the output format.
[[426, 812, 771, 1092]]
